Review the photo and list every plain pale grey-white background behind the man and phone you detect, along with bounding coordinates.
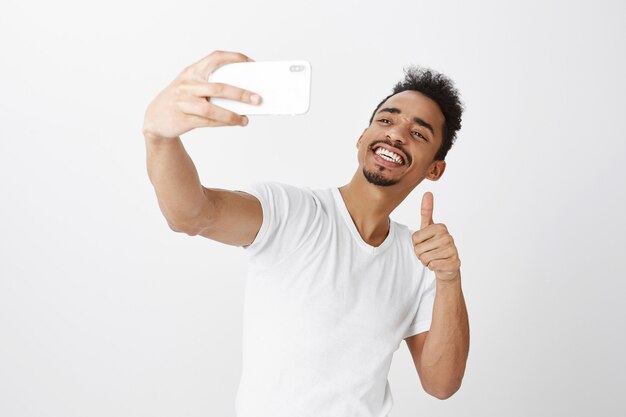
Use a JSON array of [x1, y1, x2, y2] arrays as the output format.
[[0, 1, 626, 417]]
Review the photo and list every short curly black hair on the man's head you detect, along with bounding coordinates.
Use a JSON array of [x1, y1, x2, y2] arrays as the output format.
[[369, 65, 463, 161]]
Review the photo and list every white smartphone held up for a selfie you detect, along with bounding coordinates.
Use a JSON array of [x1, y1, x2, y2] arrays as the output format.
[[208, 61, 311, 115]]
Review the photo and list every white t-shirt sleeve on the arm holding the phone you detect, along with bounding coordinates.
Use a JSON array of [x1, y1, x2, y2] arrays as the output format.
[[234, 182, 317, 266]]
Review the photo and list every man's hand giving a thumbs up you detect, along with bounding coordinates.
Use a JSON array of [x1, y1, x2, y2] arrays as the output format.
[[413, 192, 461, 281]]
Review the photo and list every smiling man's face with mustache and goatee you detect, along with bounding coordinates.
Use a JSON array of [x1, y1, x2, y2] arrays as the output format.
[[357, 91, 445, 189]]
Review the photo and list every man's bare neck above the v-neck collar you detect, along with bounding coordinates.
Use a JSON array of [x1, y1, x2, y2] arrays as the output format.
[[339, 171, 410, 246]]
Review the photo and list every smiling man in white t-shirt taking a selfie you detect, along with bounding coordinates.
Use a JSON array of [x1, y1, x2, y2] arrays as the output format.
[[143, 51, 469, 417]]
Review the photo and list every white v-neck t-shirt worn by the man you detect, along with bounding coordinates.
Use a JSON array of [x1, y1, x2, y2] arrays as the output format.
[[236, 182, 435, 417]]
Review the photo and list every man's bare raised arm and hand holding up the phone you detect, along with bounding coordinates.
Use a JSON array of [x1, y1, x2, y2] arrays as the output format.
[[143, 51, 262, 246]]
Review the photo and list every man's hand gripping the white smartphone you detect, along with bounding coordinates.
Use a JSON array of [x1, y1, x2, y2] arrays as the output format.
[[143, 51, 261, 138]]
